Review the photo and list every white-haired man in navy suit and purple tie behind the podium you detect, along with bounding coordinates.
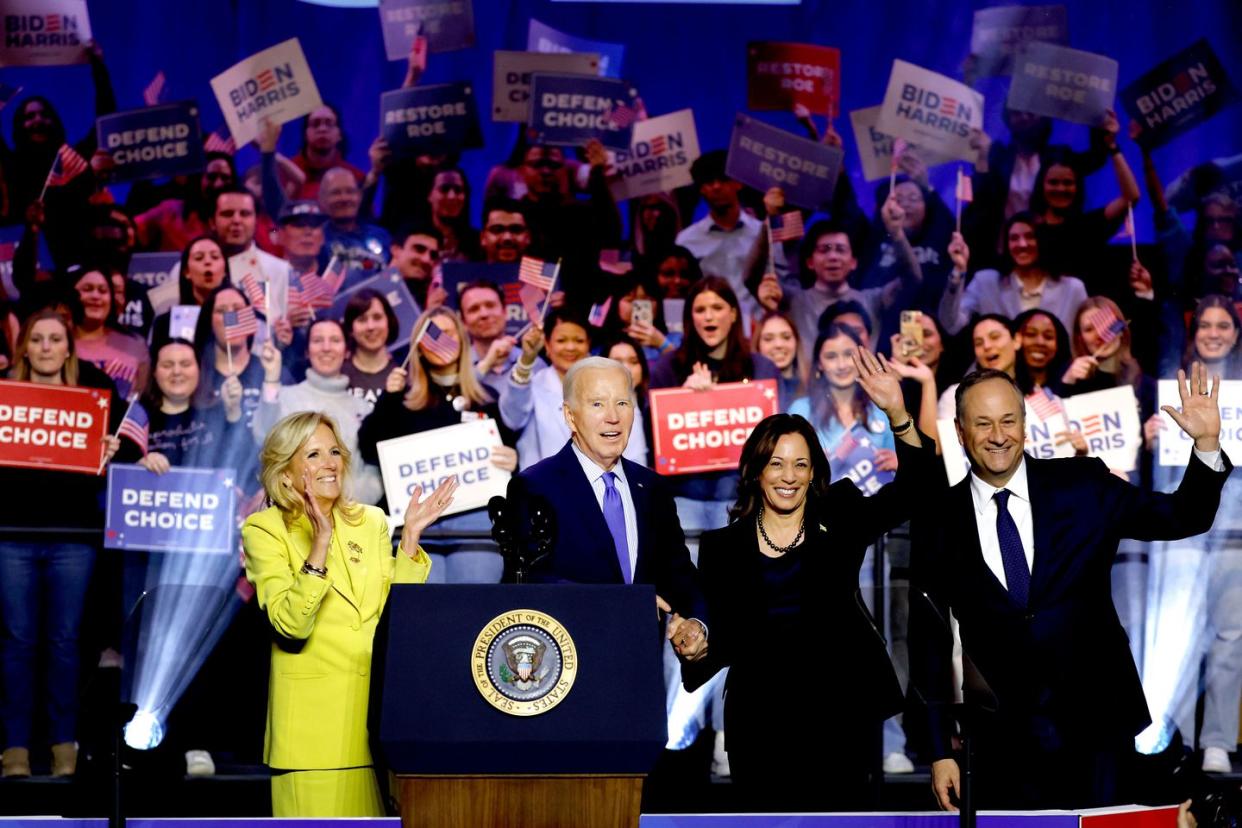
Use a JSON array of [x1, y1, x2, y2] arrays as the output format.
[[504, 356, 707, 660]]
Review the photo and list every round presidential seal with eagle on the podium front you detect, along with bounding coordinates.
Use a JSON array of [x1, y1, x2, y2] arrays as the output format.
[[471, 610, 578, 716]]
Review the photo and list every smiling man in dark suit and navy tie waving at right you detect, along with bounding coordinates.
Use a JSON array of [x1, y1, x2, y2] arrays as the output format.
[[910, 364, 1232, 809]]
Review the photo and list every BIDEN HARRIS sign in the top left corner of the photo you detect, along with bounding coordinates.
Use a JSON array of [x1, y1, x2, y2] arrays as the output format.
[[0, 0, 91, 66]]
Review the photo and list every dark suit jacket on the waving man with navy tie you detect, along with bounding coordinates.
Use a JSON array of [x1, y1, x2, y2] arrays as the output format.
[[910, 454, 1232, 758]]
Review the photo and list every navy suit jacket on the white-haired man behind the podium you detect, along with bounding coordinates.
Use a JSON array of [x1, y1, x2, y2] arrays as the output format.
[[505, 443, 707, 623]]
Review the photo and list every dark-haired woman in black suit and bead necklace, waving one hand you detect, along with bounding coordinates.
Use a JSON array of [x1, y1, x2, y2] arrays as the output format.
[[682, 351, 935, 811]]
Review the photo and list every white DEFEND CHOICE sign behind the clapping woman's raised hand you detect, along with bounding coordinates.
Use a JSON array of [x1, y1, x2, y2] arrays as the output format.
[[375, 418, 509, 526]]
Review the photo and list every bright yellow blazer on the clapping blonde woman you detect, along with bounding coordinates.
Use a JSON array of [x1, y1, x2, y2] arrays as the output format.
[[241, 505, 431, 770]]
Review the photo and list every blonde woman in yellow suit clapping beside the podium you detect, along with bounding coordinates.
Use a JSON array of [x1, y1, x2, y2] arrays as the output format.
[[242, 411, 457, 817]]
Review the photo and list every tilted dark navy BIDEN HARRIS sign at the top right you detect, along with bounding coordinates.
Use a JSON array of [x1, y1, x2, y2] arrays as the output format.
[[1122, 40, 1235, 149]]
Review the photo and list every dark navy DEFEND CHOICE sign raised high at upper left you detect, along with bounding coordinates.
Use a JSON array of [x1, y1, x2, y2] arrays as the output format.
[[94, 101, 206, 181]]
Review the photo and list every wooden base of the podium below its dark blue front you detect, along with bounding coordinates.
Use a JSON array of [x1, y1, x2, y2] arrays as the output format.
[[396, 776, 643, 828]]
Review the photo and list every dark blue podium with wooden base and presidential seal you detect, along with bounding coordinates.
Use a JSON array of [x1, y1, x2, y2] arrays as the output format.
[[370, 583, 668, 828]]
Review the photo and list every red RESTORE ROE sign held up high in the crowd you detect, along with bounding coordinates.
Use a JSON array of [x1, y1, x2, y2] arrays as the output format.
[[746, 41, 841, 117]]
